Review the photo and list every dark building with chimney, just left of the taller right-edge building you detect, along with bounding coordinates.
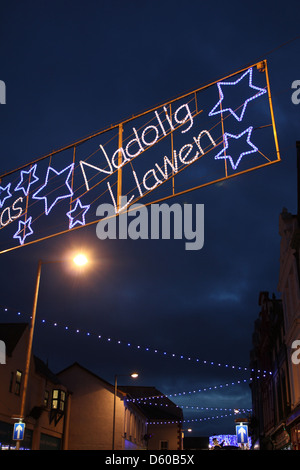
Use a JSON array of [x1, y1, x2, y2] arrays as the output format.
[[250, 292, 290, 450]]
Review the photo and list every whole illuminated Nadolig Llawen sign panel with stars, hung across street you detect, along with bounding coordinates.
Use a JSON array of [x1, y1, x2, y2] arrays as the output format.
[[0, 61, 280, 253]]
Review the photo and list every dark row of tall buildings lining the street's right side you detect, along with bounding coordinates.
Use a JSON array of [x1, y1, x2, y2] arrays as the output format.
[[251, 194, 300, 450]]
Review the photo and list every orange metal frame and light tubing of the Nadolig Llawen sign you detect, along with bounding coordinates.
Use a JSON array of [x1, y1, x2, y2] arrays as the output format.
[[0, 60, 281, 254]]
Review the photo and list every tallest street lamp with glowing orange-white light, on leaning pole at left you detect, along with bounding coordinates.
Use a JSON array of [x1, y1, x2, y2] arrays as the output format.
[[16, 254, 87, 449]]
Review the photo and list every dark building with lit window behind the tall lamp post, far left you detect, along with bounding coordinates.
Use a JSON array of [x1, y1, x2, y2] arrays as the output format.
[[0, 323, 68, 450]]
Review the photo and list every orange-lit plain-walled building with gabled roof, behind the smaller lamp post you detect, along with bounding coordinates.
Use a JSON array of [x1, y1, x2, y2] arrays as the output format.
[[58, 363, 147, 450]]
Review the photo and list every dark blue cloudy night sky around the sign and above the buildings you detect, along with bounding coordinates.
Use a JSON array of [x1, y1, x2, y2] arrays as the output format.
[[0, 0, 300, 435]]
